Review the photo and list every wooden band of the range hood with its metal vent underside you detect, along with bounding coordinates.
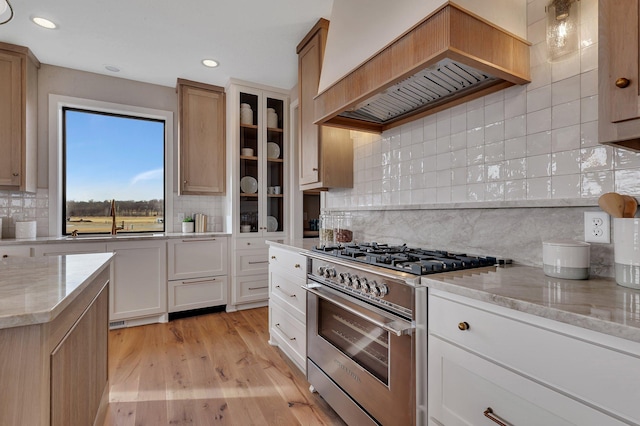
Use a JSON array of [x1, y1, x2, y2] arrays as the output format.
[[314, 2, 531, 133]]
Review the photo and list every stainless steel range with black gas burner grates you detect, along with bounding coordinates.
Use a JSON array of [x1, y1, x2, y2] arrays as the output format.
[[305, 243, 508, 425]]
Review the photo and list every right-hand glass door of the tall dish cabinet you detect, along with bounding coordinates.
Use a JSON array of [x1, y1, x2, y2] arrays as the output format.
[[265, 97, 288, 232]]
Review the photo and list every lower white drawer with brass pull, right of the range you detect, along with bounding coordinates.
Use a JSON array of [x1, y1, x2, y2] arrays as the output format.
[[428, 337, 623, 426]]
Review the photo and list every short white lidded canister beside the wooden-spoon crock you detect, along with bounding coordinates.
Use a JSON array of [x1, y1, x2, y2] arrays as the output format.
[[542, 240, 591, 280]]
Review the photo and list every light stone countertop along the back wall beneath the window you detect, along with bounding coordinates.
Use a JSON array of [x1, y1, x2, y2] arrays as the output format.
[[0, 232, 231, 246]]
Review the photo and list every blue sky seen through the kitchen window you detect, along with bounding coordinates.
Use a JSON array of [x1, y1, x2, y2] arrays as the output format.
[[66, 110, 164, 201]]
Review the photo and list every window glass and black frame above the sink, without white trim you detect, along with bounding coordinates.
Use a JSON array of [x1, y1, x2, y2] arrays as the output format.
[[62, 107, 165, 235]]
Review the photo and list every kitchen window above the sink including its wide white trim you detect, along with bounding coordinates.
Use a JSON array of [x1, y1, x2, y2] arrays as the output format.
[[49, 95, 173, 236]]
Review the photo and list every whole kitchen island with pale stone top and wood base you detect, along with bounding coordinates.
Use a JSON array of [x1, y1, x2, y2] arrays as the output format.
[[0, 253, 113, 425]]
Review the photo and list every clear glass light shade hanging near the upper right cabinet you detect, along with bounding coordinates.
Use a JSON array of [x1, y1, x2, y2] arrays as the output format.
[[547, 0, 580, 62]]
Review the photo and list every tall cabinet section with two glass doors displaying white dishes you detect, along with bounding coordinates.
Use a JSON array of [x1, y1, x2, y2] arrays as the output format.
[[229, 84, 290, 236]]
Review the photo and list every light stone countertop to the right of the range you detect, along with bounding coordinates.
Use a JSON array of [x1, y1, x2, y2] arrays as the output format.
[[422, 265, 640, 343]]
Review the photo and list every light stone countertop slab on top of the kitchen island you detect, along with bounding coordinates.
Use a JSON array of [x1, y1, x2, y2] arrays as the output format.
[[0, 253, 114, 329]]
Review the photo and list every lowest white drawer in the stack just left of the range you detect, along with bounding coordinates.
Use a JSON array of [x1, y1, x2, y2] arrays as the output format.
[[269, 302, 307, 370]]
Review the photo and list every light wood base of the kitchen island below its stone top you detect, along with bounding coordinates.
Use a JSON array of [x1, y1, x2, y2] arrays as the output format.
[[0, 266, 110, 425]]
